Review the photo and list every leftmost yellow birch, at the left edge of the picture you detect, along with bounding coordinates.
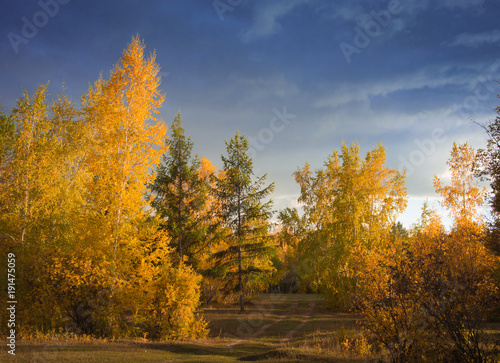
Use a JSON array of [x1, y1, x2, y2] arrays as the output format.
[[0, 85, 85, 330]]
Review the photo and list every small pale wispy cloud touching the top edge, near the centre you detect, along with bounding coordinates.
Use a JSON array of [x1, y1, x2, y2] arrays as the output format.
[[242, 0, 309, 42]]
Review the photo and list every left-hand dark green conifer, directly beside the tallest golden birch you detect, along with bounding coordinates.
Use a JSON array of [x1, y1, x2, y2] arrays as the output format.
[[150, 112, 208, 265]]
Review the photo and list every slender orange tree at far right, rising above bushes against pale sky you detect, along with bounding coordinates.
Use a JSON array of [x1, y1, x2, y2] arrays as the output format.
[[430, 143, 498, 361]]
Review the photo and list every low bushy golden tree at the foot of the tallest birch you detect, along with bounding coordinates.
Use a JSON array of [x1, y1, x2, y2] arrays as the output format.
[[127, 225, 208, 340]]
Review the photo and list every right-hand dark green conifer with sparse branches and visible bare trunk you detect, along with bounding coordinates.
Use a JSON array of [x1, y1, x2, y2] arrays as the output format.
[[214, 132, 274, 312]]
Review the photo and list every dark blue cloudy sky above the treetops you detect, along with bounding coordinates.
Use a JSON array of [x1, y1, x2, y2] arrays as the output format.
[[0, 0, 500, 225]]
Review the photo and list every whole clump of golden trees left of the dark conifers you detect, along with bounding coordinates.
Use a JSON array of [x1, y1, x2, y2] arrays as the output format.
[[0, 37, 206, 338]]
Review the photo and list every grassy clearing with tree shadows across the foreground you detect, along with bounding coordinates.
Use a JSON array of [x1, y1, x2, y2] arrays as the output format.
[[0, 294, 500, 362]]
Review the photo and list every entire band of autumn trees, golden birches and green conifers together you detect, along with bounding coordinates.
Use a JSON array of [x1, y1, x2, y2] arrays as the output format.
[[0, 36, 500, 362]]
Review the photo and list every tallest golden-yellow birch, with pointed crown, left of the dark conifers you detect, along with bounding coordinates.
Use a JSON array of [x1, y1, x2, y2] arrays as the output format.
[[82, 36, 166, 328]]
